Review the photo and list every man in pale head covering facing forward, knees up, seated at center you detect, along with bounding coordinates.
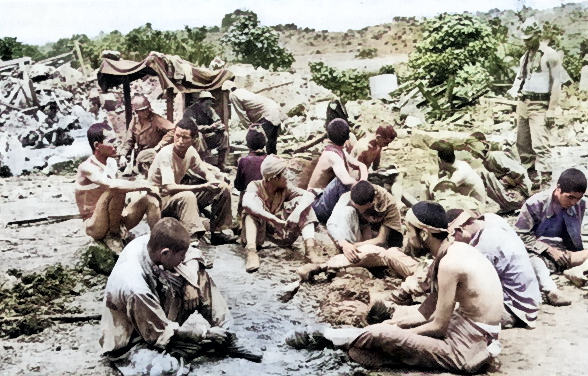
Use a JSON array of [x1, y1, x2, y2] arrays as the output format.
[[241, 154, 317, 273]]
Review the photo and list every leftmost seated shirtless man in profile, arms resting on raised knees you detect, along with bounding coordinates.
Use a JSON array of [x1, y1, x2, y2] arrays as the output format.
[[75, 123, 160, 253]]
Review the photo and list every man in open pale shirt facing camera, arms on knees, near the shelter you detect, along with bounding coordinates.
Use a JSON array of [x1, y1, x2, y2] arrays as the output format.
[[148, 119, 234, 245]]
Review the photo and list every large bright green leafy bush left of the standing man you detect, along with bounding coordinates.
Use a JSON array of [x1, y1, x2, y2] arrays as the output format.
[[408, 13, 497, 86]]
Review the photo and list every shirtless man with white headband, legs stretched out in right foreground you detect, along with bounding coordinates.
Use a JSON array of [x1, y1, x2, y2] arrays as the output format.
[[286, 201, 503, 373]]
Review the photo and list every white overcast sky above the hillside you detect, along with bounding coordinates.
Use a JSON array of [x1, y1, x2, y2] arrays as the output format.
[[0, 0, 581, 44]]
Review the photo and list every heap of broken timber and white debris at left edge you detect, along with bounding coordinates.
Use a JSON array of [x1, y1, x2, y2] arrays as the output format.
[[0, 58, 96, 176]]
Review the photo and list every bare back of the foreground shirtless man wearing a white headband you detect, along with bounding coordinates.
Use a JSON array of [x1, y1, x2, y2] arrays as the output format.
[[437, 242, 504, 325]]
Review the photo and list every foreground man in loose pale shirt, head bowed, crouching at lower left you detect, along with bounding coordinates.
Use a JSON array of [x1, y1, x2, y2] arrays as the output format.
[[100, 218, 261, 375]]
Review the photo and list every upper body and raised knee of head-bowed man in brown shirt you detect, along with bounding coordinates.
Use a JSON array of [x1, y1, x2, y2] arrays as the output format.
[[327, 181, 402, 263]]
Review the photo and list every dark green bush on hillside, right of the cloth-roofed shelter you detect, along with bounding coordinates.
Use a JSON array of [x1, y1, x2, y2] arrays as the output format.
[[221, 13, 294, 71]]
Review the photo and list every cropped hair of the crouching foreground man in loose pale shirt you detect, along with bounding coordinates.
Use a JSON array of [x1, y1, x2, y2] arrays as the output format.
[[147, 217, 190, 253]]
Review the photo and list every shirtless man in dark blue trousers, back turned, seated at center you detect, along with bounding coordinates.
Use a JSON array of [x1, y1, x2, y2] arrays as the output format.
[[308, 119, 368, 224]]
